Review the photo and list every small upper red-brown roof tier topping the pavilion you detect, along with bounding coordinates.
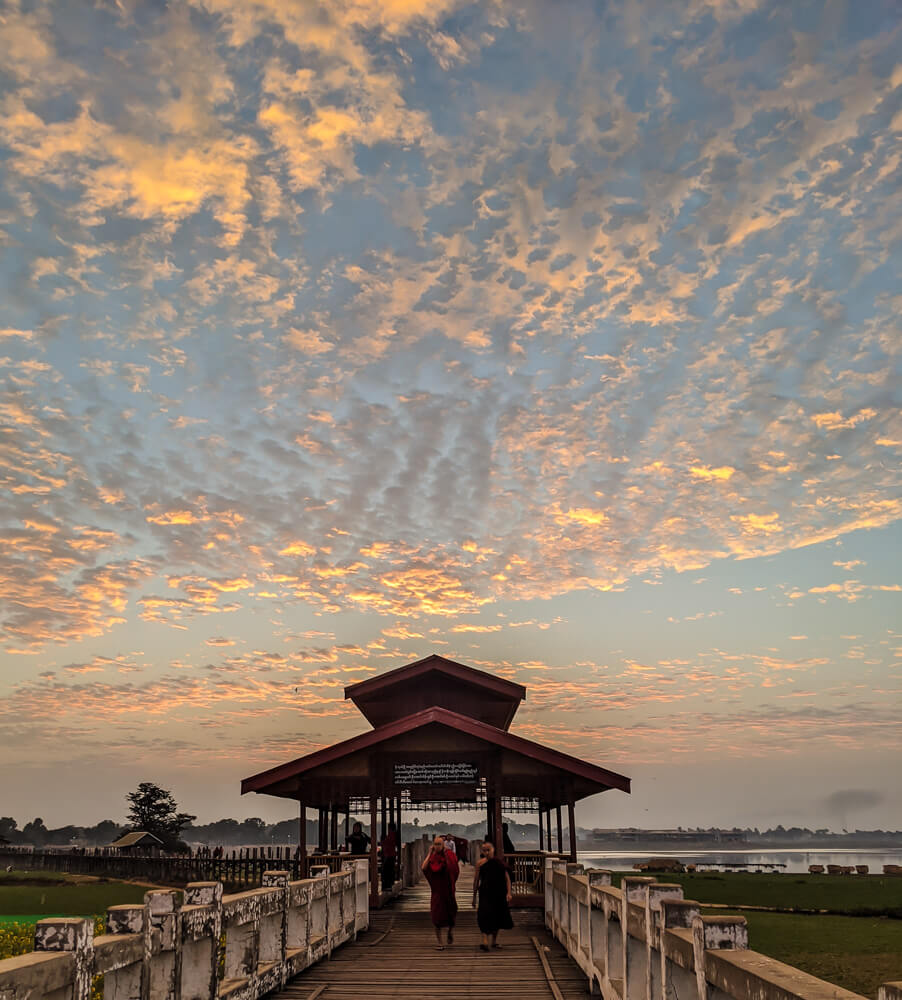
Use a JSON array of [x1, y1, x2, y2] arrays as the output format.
[[345, 654, 526, 729]]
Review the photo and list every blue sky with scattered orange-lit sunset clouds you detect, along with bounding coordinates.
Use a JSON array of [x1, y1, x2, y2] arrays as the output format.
[[0, 0, 902, 830]]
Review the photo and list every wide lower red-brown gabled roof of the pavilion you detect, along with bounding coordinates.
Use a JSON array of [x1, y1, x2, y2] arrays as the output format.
[[241, 704, 630, 805]]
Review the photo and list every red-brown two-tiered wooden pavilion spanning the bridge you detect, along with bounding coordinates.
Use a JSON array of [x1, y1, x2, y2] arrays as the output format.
[[241, 655, 630, 908]]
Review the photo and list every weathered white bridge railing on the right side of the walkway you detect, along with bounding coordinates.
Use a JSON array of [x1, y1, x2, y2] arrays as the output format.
[[544, 859, 902, 1000]]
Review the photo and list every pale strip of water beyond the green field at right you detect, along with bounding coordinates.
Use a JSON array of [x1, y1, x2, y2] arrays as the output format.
[[577, 848, 902, 875]]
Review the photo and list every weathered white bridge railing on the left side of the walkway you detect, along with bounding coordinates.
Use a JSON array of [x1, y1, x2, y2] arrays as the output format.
[[0, 862, 369, 1000]]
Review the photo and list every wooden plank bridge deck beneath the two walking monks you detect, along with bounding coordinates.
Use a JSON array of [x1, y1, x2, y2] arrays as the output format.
[[278, 866, 586, 1000]]
